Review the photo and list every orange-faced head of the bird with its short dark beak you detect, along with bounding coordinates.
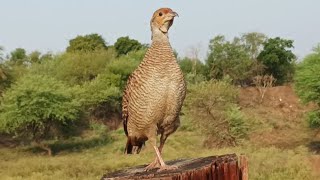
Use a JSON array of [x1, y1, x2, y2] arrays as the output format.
[[150, 8, 178, 38]]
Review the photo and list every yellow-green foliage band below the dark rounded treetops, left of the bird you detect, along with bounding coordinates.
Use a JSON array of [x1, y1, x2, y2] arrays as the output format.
[[31, 49, 115, 85]]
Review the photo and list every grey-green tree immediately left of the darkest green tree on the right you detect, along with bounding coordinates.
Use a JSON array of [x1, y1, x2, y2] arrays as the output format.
[[207, 35, 253, 84]]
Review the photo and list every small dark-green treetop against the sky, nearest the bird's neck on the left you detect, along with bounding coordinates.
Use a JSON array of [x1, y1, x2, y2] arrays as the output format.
[[114, 36, 143, 56]]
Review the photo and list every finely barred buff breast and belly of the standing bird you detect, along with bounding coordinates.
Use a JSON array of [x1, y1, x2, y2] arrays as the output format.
[[128, 41, 185, 134]]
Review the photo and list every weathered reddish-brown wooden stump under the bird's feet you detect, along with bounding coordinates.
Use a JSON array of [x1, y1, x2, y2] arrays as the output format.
[[101, 154, 248, 180]]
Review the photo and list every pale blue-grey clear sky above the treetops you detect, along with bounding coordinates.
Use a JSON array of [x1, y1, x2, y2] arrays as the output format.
[[0, 0, 320, 59]]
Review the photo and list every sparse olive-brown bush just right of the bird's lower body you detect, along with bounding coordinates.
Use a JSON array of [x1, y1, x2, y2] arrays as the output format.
[[185, 81, 248, 146]]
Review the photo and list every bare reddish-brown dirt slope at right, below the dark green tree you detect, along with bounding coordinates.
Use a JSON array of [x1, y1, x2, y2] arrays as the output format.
[[239, 85, 320, 176]]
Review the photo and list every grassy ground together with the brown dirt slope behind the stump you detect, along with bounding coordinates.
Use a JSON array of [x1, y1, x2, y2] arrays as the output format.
[[0, 87, 320, 180]]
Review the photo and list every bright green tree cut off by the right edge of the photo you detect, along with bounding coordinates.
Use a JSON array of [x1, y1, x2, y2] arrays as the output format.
[[294, 45, 320, 127]]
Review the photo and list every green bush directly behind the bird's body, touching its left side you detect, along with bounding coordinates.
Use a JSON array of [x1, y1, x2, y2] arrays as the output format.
[[73, 51, 145, 129]]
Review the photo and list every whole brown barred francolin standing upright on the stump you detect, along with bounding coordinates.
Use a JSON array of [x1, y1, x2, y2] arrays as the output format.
[[122, 8, 186, 170]]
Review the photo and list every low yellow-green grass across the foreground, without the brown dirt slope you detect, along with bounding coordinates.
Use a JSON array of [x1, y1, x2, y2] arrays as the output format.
[[0, 117, 319, 180]]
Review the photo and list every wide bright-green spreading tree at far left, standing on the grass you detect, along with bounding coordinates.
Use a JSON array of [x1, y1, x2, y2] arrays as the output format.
[[0, 75, 81, 155]]
